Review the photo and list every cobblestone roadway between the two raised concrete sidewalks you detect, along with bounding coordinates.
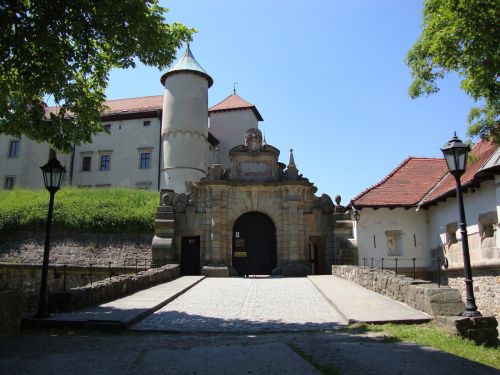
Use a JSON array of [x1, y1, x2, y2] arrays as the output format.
[[133, 278, 344, 332]]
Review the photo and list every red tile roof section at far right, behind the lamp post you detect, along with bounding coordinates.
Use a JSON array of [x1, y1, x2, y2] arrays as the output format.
[[421, 141, 497, 206]]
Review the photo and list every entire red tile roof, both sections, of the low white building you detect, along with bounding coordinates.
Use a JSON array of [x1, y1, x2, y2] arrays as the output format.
[[351, 141, 497, 208]]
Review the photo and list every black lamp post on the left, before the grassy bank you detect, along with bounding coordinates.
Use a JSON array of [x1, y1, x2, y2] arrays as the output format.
[[35, 153, 66, 318]]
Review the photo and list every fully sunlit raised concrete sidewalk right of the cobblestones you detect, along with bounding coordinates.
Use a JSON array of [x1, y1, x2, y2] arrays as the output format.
[[308, 275, 433, 324]]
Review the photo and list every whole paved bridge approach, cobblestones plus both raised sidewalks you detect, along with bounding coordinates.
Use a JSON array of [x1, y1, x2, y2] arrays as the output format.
[[35, 275, 432, 332]]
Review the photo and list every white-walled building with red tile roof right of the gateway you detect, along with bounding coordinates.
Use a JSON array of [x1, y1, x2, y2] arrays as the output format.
[[351, 142, 500, 317]]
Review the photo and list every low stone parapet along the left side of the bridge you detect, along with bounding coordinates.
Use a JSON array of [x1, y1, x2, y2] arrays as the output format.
[[49, 264, 180, 312]]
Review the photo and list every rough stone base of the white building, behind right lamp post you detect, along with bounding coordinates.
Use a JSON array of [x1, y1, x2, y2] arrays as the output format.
[[442, 267, 500, 319]]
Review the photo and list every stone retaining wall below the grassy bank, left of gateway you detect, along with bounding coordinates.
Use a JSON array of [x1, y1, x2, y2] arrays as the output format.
[[0, 229, 153, 268]]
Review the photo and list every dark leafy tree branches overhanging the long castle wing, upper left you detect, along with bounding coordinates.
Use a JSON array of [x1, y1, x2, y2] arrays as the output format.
[[0, 0, 195, 152]]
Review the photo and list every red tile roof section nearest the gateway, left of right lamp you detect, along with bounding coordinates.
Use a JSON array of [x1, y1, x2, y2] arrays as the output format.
[[351, 157, 448, 208]]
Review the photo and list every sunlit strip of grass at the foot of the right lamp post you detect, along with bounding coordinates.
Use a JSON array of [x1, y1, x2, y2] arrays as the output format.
[[366, 323, 500, 369]]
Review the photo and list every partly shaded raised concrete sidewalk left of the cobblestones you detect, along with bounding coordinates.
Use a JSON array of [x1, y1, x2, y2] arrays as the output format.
[[22, 276, 205, 328]]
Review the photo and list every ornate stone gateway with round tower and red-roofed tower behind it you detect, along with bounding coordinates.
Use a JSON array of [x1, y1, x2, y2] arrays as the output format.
[[152, 47, 352, 276]]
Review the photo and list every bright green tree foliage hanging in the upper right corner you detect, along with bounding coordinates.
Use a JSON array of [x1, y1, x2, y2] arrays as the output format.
[[405, 0, 500, 144]]
